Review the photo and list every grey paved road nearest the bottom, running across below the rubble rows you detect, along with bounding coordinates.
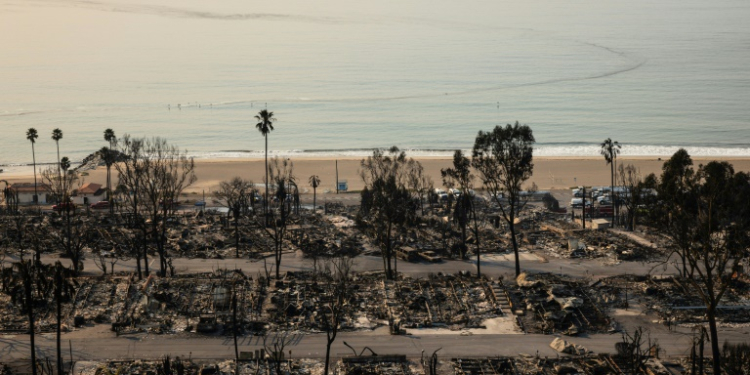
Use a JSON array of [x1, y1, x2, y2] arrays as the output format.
[[5, 326, 750, 360]]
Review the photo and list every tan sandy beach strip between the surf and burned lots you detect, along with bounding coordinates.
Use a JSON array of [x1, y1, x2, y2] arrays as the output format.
[[0, 157, 750, 194]]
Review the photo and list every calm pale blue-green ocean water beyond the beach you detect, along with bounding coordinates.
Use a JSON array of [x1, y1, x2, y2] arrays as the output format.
[[0, 0, 750, 170]]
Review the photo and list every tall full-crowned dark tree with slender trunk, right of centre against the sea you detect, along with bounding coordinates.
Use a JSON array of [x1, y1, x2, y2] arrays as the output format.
[[472, 122, 535, 276]]
